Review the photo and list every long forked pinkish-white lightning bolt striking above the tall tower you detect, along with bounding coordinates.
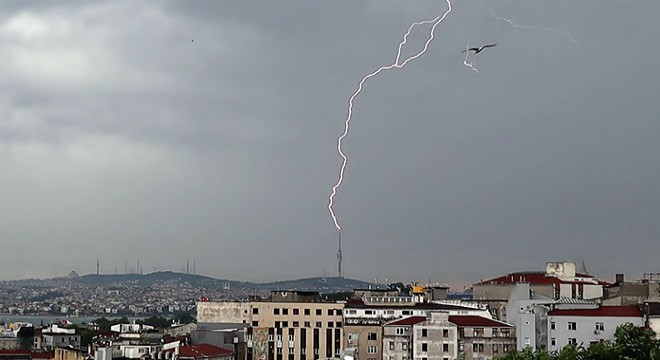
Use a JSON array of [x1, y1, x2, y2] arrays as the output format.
[[328, 0, 451, 231]]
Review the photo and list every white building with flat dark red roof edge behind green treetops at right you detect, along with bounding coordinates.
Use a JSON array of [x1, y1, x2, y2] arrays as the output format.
[[548, 305, 644, 351]]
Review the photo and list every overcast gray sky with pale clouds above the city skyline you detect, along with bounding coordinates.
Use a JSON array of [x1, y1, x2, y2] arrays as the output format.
[[0, 0, 660, 282]]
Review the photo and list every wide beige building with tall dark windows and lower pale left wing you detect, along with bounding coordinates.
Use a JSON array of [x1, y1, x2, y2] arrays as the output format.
[[197, 291, 344, 360]]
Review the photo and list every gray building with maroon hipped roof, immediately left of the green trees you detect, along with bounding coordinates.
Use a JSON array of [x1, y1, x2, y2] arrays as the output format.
[[449, 315, 516, 360]]
